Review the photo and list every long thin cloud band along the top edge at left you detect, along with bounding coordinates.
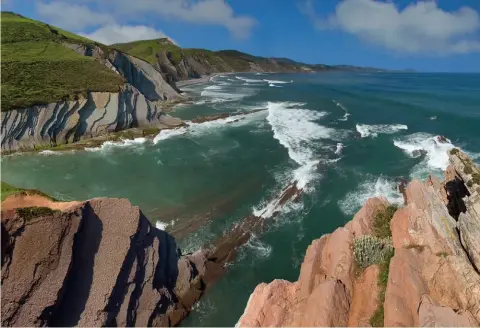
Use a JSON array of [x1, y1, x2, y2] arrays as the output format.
[[37, 0, 256, 38]]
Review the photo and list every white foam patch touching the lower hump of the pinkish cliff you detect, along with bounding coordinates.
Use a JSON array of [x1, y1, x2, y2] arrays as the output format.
[[338, 177, 403, 215]]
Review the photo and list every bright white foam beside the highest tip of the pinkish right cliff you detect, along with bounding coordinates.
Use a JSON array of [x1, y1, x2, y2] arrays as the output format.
[[393, 132, 455, 175]]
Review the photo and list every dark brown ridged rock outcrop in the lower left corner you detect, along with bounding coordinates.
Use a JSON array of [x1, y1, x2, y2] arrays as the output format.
[[2, 196, 221, 326]]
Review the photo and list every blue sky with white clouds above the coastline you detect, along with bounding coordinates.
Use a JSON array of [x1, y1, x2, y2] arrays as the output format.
[[1, 0, 480, 72]]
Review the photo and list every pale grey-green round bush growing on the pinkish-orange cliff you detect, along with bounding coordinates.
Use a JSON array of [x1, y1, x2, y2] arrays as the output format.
[[353, 235, 393, 268]]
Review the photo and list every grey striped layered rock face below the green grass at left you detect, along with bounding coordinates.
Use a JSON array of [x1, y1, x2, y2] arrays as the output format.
[[1, 44, 183, 151]]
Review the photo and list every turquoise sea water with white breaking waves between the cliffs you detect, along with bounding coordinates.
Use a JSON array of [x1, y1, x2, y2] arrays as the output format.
[[2, 73, 480, 326]]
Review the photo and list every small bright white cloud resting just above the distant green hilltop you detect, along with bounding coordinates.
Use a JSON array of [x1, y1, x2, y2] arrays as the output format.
[[80, 24, 176, 44]]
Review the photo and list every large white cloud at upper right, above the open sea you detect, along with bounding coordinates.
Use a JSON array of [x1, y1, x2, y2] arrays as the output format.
[[301, 0, 480, 55]]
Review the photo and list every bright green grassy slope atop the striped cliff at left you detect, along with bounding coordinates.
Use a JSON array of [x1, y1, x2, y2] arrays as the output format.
[[1, 12, 125, 111]]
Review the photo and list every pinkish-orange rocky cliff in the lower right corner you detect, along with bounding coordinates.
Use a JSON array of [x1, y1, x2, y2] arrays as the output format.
[[237, 149, 480, 327]]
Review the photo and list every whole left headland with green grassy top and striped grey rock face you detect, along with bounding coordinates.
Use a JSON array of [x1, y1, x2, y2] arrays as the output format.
[[1, 13, 184, 150]]
